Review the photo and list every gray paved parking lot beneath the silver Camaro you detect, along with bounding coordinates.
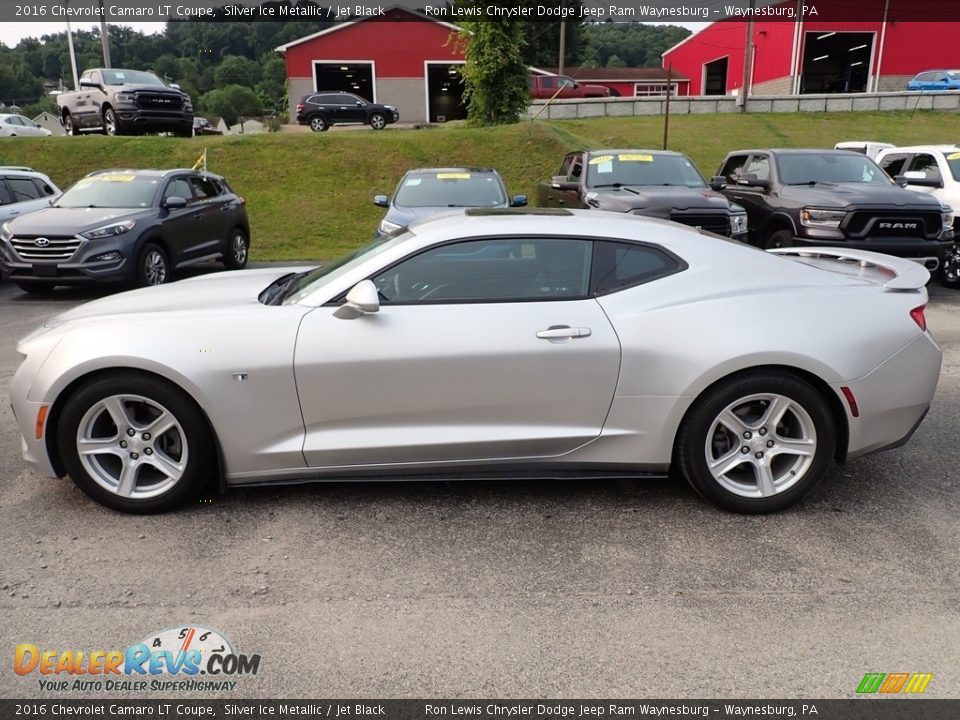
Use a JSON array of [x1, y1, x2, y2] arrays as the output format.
[[0, 270, 960, 698]]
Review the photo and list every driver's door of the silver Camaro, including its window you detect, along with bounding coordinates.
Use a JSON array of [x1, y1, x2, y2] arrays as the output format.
[[294, 237, 620, 467]]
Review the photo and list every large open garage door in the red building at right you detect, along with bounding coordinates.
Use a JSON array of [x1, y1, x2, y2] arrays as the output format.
[[800, 32, 874, 93]]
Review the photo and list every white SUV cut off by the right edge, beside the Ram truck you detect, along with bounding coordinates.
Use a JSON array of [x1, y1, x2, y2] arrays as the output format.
[[877, 145, 960, 288]]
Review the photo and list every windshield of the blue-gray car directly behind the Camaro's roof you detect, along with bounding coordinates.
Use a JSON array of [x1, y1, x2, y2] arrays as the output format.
[[393, 171, 507, 207]]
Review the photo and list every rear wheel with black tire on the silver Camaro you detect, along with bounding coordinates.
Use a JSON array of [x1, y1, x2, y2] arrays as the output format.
[[676, 370, 836, 513]]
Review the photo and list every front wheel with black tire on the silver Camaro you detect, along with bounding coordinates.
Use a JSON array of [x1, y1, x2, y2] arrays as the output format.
[[57, 371, 215, 514]]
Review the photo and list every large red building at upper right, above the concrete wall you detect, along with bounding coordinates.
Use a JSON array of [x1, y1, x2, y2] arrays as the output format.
[[663, 0, 960, 95]]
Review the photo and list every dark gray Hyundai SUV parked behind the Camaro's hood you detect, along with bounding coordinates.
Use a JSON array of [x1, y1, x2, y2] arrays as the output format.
[[0, 170, 250, 292]]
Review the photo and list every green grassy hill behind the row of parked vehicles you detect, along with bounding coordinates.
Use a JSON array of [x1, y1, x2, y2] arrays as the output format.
[[0, 111, 957, 260]]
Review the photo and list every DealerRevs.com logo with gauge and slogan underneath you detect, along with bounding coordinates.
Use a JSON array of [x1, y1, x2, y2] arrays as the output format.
[[13, 625, 260, 692]]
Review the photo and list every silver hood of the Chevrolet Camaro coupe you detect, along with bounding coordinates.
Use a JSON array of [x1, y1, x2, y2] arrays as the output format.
[[46, 267, 308, 327]]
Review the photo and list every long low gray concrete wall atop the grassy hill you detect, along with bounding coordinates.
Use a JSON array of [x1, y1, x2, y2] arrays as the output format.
[[527, 90, 960, 120]]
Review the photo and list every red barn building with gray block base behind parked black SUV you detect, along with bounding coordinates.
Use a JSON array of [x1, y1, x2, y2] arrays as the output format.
[[277, 8, 466, 123]]
